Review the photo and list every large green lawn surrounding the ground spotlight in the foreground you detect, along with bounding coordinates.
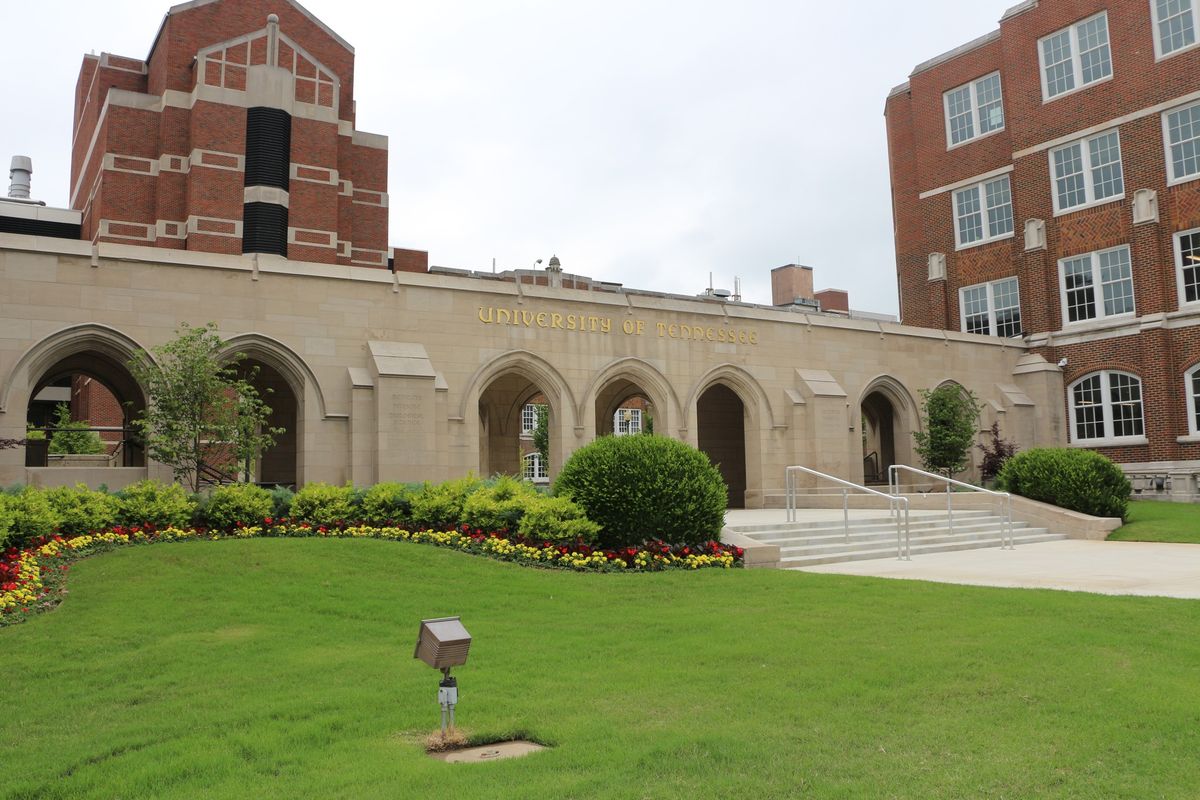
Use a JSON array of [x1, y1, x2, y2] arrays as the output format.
[[0, 539, 1200, 800]]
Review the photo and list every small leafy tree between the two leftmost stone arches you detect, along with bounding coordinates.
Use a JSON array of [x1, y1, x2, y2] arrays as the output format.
[[130, 323, 283, 492]]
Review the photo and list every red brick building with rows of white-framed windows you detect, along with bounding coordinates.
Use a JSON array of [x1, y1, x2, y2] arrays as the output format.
[[886, 0, 1200, 499]]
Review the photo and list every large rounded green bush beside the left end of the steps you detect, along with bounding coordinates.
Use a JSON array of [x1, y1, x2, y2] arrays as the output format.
[[554, 435, 728, 547]]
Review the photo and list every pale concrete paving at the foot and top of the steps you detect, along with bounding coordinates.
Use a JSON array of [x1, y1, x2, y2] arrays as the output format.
[[725, 509, 1200, 599]]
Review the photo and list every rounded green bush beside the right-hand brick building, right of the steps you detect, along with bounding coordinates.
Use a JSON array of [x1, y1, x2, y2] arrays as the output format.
[[996, 447, 1130, 519]]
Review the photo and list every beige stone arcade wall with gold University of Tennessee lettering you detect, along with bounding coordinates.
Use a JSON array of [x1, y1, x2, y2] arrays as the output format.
[[0, 235, 1064, 506]]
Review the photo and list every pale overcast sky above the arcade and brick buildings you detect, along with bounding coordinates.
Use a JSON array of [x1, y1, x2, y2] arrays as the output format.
[[0, 0, 1015, 313]]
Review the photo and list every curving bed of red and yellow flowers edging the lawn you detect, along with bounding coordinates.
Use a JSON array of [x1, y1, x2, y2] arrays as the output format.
[[0, 517, 743, 626]]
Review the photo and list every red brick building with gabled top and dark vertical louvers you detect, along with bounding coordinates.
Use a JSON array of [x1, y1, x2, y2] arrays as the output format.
[[71, 0, 427, 271]]
